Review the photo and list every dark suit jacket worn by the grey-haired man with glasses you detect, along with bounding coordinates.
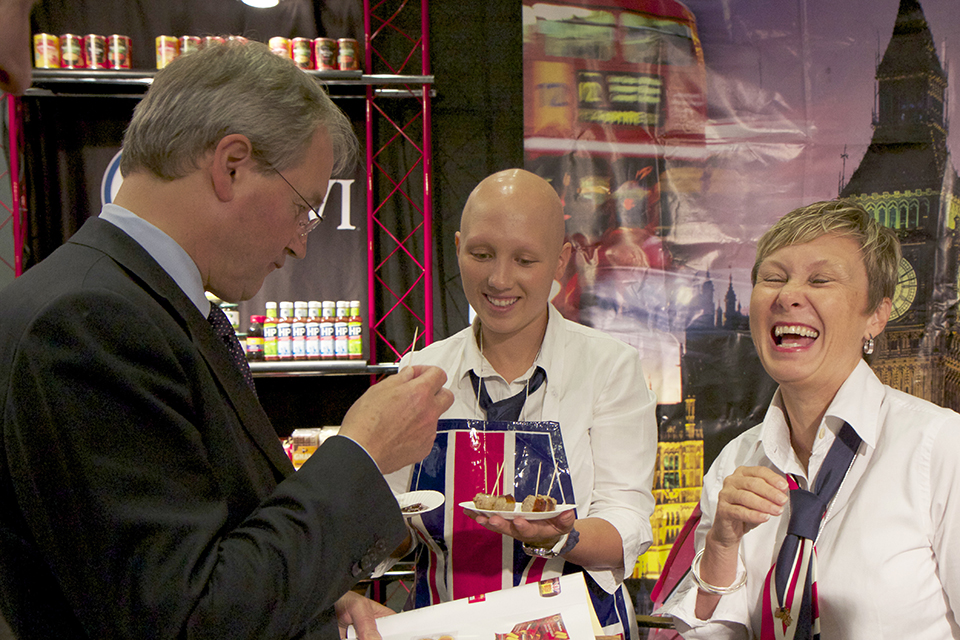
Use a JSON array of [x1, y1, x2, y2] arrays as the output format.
[[0, 219, 406, 640]]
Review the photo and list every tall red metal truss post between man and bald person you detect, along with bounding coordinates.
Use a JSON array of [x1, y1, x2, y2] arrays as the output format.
[[364, 0, 433, 364]]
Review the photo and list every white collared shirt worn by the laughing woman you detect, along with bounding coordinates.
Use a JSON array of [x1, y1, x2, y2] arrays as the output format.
[[657, 361, 960, 640]]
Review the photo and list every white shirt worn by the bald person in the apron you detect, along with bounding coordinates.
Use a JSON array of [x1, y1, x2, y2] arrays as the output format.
[[387, 304, 657, 593]]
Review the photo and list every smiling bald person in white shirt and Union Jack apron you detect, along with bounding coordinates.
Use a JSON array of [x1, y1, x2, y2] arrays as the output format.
[[388, 169, 657, 638]]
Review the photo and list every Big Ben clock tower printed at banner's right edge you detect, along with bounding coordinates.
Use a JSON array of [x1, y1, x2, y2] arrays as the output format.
[[840, 0, 960, 409]]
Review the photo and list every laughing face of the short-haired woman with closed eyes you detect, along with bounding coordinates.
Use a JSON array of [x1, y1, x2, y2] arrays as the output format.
[[750, 234, 890, 403]]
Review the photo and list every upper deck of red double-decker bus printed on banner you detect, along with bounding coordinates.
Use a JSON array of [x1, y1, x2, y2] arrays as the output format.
[[523, 0, 706, 156]]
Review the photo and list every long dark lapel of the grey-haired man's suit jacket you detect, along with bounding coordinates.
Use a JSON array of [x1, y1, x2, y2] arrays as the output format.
[[69, 218, 293, 475]]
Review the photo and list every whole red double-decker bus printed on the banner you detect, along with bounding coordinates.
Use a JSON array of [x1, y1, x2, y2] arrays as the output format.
[[523, 0, 707, 321]]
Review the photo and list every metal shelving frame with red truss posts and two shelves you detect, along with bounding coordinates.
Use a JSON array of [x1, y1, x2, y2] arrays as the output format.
[[0, 0, 434, 376]]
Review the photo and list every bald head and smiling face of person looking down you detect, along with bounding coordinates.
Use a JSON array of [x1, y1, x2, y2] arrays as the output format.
[[456, 170, 570, 346]]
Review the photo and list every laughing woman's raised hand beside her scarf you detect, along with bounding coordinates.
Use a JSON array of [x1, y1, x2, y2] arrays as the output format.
[[710, 467, 788, 548]]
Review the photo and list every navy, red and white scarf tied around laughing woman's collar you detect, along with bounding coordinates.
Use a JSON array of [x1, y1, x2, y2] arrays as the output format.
[[760, 422, 860, 640]]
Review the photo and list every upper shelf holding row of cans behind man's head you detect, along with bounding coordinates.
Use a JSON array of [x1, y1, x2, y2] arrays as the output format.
[[25, 69, 433, 98]]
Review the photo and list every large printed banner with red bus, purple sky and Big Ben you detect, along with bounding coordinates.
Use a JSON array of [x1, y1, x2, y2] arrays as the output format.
[[523, 0, 960, 596]]
